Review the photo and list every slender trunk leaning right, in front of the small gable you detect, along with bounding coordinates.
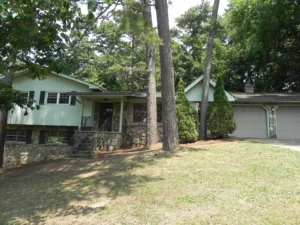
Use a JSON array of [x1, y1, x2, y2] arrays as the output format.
[[200, 0, 220, 140]]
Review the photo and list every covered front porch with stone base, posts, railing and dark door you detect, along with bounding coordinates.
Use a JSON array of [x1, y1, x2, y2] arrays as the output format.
[[68, 92, 162, 152]]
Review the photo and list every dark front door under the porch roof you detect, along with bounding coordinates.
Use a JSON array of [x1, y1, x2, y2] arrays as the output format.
[[99, 103, 113, 131]]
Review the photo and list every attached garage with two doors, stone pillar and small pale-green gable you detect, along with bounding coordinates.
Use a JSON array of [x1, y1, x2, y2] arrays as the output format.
[[185, 76, 300, 140]]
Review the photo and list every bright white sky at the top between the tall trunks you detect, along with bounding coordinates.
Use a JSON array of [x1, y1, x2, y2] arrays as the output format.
[[153, 0, 228, 27]]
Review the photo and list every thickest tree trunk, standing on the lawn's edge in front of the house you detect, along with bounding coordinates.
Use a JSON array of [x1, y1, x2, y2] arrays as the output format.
[[155, 0, 179, 150]]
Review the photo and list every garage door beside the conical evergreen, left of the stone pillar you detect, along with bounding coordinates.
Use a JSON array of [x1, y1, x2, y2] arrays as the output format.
[[232, 106, 267, 138]]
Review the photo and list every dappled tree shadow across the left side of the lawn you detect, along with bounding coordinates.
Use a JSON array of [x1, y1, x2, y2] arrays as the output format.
[[0, 151, 179, 224]]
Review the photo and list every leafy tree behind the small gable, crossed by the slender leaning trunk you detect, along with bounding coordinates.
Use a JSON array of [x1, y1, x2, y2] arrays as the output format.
[[171, 1, 228, 89]]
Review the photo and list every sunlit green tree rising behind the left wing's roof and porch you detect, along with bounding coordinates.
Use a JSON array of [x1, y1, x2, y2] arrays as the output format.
[[66, 19, 146, 91]]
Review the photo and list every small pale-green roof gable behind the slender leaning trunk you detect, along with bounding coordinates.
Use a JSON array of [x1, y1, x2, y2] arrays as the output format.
[[184, 75, 236, 102]]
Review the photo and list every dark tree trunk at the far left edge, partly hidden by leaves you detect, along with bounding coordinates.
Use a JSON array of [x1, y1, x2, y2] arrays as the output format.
[[0, 72, 13, 167]]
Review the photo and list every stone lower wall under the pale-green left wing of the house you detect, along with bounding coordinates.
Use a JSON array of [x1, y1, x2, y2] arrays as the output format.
[[4, 130, 71, 167]]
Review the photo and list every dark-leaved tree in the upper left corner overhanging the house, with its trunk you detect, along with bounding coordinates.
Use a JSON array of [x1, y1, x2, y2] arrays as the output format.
[[0, 0, 78, 167]]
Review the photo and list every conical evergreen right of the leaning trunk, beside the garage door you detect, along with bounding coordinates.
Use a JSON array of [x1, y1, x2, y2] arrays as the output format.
[[207, 77, 236, 138]]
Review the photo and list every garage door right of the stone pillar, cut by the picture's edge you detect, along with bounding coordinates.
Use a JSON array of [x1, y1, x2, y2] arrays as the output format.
[[276, 107, 300, 139]]
